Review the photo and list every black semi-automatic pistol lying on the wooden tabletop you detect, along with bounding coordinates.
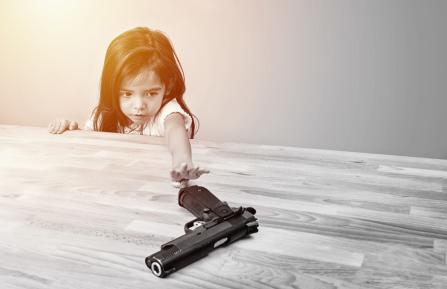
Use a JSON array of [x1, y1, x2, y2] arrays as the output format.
[[146, 186, 259, 277]]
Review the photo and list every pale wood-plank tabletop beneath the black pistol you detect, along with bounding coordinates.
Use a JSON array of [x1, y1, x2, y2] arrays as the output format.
[[0, 125, 447, 289]]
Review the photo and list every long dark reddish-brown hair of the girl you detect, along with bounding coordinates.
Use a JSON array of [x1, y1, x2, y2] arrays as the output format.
[[92, 27, 196, 138]]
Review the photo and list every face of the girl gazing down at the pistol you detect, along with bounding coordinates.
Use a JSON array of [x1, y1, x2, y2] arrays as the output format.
[[119, 69, 166, 124]]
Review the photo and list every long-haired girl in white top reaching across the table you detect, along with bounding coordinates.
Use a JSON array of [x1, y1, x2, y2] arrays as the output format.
[[48, 27, 209, 186]]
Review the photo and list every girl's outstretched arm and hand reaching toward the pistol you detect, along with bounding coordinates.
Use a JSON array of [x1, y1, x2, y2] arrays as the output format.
[[165, 113, 209, 182]]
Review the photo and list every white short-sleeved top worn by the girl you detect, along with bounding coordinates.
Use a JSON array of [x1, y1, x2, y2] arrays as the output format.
[[84, 99, 192, 136]]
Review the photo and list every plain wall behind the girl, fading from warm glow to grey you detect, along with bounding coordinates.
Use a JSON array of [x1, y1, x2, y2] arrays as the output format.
[[0, 0, 447, 158]]
